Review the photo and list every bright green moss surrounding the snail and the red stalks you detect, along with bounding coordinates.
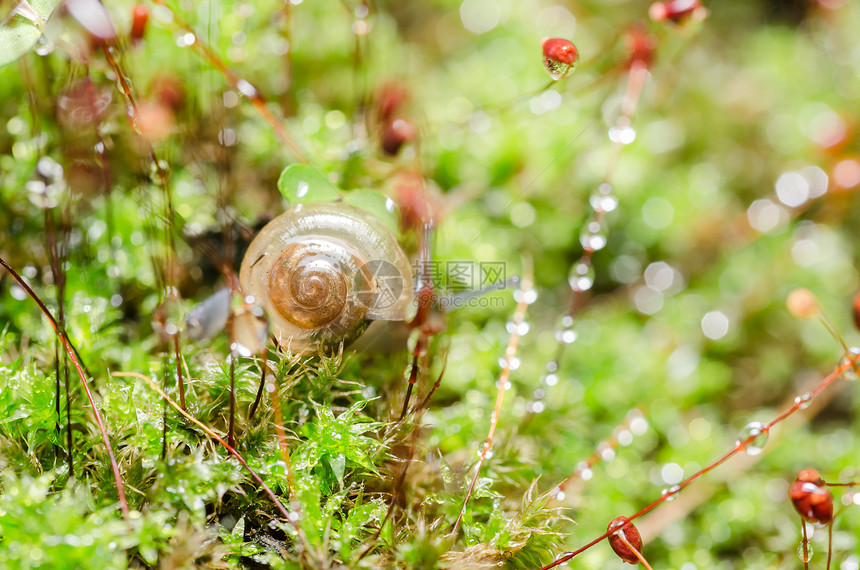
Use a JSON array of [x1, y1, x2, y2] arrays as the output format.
[[0, 0, 860, 570]]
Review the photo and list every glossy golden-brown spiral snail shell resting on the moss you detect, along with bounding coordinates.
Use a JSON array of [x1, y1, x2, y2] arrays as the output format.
[[239, 203, 412, 352]]
